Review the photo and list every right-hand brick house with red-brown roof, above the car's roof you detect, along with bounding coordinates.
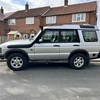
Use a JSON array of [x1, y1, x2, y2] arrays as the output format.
[[42, 0, 97, 26]]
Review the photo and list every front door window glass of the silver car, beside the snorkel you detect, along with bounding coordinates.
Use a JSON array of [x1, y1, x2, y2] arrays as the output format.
[[42, 30, 59, 43]]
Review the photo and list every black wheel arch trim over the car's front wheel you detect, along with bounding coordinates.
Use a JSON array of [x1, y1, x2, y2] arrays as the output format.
[[5, 49, 29, 60]]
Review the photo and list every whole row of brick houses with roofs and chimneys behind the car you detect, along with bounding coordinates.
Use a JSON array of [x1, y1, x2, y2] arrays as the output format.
[[0, 0, 97, 41]]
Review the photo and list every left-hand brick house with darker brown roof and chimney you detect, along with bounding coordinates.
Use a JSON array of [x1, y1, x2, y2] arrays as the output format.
[[6, 3, 50, 38]]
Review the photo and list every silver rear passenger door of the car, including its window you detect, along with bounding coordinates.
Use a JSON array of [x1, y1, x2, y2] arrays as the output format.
[[60, 29, 80, 59]]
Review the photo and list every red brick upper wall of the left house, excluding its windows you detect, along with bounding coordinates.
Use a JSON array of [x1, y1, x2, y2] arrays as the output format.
[[9, 17, 40, 33]]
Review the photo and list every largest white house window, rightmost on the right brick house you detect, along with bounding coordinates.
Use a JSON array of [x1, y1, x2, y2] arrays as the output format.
[[72, 13, 86, 22]]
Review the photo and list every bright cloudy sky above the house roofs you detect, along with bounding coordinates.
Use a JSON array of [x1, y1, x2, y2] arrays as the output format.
[[0, 0, 96, 12]]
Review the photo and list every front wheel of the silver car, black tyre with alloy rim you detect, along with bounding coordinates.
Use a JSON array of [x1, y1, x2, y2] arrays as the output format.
[[7, 53, 28, 71]]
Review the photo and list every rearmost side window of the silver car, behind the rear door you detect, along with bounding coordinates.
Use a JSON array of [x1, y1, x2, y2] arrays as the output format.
[[82, 30, 98, 42]]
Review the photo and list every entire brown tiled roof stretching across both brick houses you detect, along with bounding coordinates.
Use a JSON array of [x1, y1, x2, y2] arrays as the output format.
[[6, 1, 97, 19]]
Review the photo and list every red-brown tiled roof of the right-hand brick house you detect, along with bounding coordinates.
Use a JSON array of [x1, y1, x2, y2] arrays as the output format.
[[44, 1, 97, 16]]
